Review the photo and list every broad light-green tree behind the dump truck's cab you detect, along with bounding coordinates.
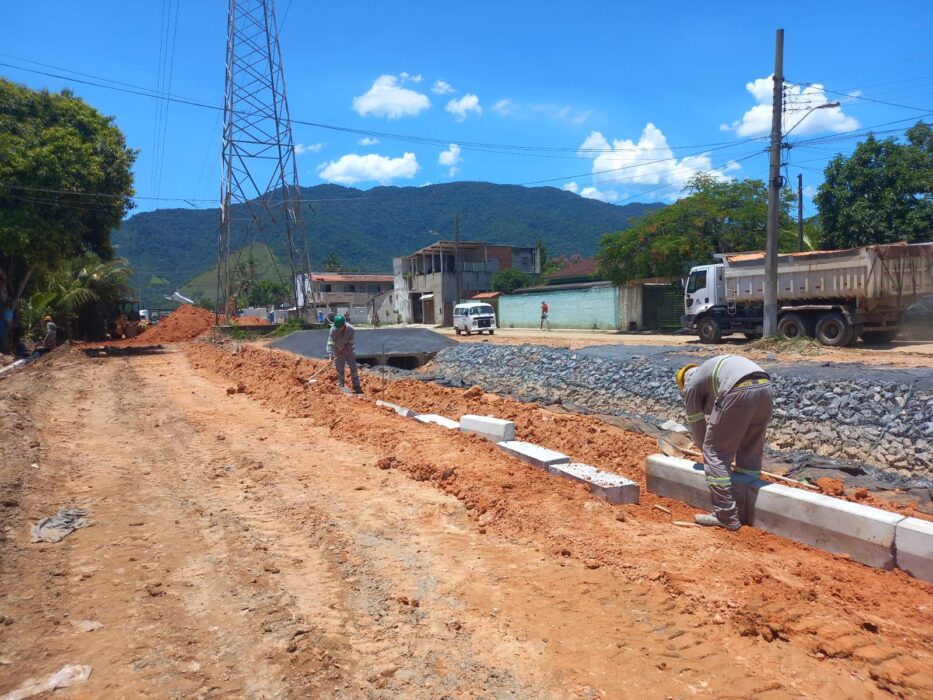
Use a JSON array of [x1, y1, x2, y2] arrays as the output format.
[[596, 173, 796, 284]]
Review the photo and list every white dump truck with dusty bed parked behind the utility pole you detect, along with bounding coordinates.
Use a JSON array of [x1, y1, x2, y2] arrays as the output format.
[[682, 243, 933, 347]]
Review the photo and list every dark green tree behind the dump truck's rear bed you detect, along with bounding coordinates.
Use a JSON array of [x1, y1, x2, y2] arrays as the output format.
[[814, 121, 933, 248]]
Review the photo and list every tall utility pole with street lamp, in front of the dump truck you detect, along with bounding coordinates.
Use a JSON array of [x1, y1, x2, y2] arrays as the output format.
[[762, 29, 784, 338]]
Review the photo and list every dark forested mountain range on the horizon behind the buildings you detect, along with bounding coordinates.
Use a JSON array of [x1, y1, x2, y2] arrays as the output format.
[[112, 182, 662, 307]]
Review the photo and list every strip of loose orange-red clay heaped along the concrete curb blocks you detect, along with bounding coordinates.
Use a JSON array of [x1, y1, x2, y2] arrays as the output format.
[[186, 343, 933, 697]]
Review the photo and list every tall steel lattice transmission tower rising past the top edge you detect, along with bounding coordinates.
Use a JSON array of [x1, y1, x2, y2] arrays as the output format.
[[216, 0, 310, 322]]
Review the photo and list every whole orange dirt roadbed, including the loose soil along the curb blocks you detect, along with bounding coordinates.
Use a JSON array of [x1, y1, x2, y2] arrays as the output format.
[[0, 345, 933, 698]]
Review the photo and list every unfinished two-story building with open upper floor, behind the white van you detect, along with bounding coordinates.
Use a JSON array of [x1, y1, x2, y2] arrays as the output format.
[[392, 241, 541, 326]]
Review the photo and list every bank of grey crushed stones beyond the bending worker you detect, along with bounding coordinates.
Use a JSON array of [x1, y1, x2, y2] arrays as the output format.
[[431, 343, 933, 477]]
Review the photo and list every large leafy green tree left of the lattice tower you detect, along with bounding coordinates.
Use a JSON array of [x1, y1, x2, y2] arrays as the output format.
[[0, 78, 136, 322]]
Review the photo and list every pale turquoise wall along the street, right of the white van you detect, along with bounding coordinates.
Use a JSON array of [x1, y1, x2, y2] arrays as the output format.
[[498, 285, 619, 329]]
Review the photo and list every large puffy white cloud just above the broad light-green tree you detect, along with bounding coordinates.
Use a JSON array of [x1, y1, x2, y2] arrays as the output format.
[[579, 122, 741, 201]]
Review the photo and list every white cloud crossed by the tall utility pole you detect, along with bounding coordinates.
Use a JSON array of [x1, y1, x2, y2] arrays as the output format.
[[719, 76, 859, 136]]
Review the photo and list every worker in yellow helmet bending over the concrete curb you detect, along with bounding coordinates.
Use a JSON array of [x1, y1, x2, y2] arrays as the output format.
[[676, 355, 773, 530]]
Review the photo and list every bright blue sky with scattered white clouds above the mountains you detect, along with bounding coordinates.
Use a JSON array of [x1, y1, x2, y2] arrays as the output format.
[[0, 0, 933, 211]]
